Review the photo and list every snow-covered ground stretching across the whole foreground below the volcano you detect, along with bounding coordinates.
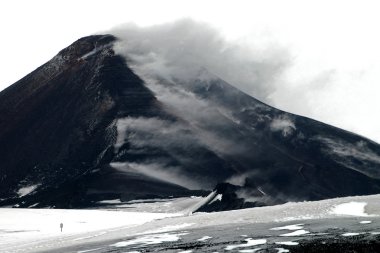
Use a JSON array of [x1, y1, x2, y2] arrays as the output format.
[[0, 194, 380, 252]]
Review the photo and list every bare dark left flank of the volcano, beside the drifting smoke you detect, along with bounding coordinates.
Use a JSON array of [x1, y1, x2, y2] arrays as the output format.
[[0, 36, 194, 207]]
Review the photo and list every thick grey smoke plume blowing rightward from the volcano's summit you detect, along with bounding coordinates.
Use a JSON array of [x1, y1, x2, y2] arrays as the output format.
[[111, 19, 290, 99]]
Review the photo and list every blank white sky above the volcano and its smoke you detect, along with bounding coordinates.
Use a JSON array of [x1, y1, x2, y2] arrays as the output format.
[[0, 0, 380, 142]]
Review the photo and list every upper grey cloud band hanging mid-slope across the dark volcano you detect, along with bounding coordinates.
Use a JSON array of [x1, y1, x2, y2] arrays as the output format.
[[115, 114, 243, 154]]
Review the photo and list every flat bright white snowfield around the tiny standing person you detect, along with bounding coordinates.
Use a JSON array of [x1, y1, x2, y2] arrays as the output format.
[[0, 208, 178, 252]]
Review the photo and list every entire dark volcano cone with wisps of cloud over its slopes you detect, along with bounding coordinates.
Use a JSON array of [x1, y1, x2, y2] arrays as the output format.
[[0, 35, 380, 210]]
